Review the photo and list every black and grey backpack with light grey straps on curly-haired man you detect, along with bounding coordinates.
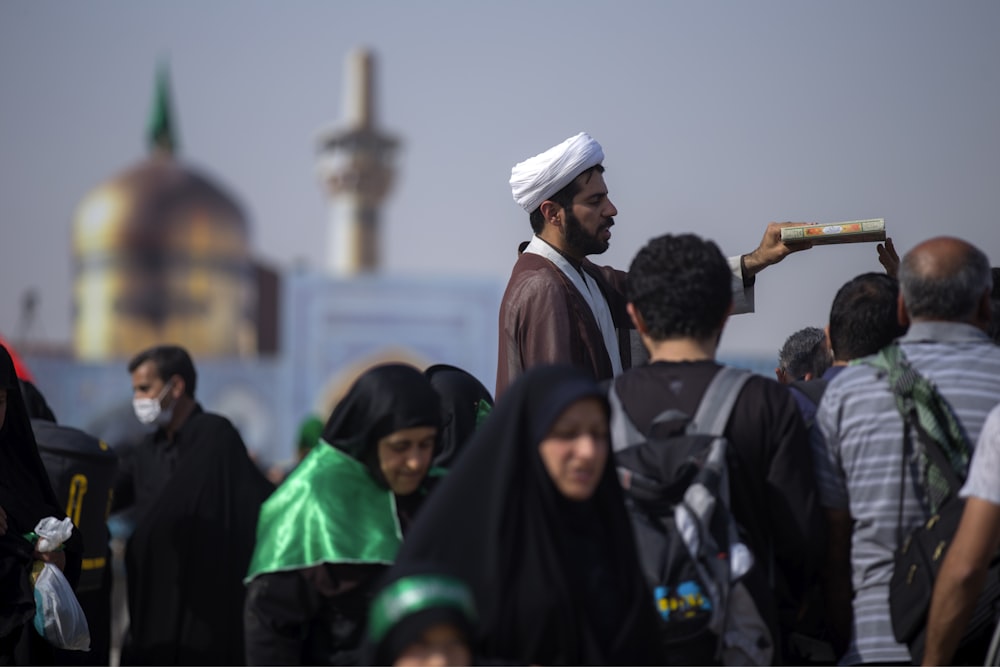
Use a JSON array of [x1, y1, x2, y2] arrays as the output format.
[[608, 367, 774, 665]]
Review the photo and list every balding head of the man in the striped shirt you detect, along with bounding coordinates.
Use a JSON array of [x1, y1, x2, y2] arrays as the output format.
[[899, 236, 993, 322]]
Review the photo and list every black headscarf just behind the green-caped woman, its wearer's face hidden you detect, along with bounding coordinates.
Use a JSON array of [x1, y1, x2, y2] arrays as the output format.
[[424, 364, 493, 468]]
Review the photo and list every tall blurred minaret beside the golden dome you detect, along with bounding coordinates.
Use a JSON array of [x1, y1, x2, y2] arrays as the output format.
[[319, 49, 399, 276]]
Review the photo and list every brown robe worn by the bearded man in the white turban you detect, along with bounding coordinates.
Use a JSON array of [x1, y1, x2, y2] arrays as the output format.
[[495, 252, 632, 398]]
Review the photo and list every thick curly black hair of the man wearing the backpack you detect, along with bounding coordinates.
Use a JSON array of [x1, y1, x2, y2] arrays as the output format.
[[626, 234, 733, 341]]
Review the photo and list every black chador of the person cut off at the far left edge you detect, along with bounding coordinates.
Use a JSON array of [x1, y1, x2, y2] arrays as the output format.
[[0, 345, 73, 637]]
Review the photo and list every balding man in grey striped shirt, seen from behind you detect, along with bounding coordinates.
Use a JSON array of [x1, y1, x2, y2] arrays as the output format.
[[816, 237, 1000, 664]]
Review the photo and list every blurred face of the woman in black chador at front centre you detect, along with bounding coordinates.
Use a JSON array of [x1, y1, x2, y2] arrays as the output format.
[[538, 398, 608, 501]]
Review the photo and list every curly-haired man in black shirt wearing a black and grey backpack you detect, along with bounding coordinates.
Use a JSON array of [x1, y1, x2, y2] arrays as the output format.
[[611, 234, 825, 664]]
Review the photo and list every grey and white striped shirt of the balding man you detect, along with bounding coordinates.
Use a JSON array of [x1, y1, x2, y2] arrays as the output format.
[[816, 322, 1000, 664]]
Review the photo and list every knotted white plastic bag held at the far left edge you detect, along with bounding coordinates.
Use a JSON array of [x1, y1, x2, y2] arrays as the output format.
[[35, 517, 90, 651]]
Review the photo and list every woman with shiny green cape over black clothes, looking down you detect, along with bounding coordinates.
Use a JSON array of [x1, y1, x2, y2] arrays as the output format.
[[244, 364, 441, 665]]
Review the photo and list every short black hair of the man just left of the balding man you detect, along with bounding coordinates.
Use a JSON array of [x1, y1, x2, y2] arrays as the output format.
[[830, 272, 906, 361]]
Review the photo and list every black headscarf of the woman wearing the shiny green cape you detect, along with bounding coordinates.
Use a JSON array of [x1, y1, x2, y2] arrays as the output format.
[[323, 364, 441, 487]]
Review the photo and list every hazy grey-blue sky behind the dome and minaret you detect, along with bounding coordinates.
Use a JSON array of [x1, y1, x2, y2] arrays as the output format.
[[0, 0, 1000, 362]]
